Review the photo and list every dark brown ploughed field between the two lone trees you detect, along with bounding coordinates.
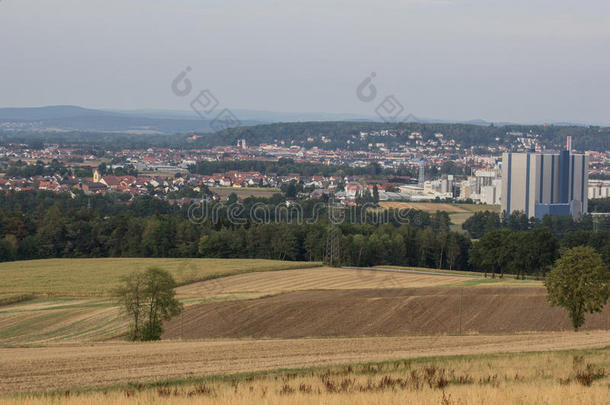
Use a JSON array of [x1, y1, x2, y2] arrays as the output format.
[[164, 286, 610, 339]]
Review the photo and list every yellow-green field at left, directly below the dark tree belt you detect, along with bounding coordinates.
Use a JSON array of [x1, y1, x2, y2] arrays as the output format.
[[0, 258, 320, 297]]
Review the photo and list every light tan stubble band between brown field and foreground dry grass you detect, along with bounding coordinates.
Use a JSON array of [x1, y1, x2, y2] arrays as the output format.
[[0, 331, 610, 394]]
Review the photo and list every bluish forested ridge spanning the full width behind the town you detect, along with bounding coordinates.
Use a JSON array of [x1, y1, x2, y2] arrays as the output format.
[[0, 121, 610, 153]]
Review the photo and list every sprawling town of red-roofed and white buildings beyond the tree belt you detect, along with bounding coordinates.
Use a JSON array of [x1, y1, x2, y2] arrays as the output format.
[[0, 130, 610, 205]]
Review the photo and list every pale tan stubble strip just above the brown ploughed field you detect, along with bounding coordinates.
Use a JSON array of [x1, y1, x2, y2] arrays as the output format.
[[176, 267, 475, 296]]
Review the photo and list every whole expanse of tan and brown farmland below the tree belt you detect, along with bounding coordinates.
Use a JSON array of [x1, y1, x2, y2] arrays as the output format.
[[0, 259, 610, 404]]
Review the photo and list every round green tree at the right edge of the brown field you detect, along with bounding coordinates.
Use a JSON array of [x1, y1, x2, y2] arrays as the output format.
[[544, 246, 610, 331]]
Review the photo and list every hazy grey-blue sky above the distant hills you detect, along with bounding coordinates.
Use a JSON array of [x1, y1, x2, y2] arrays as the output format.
[[0, 0, 610, 123]]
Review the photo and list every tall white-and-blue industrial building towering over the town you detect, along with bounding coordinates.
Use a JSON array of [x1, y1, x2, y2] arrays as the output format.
[[502, 139, 589, 218]]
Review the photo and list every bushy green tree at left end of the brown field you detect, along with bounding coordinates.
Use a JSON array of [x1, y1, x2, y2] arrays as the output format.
[[118, 267, 182, 340]]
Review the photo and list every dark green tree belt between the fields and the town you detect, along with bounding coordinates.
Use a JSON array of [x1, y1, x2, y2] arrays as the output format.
[[0, 191, 610, 276]]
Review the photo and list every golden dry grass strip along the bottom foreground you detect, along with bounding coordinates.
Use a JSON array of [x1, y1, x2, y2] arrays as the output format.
[[4, 349, 610, 405]]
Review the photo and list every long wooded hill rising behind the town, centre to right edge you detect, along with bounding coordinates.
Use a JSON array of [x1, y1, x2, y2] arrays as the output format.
[[196, 121, 610, 152]]
